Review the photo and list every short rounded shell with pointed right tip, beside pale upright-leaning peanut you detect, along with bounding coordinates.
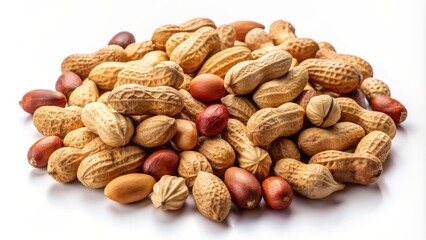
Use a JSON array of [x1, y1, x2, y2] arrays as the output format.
[[133, 115, 177, 148]]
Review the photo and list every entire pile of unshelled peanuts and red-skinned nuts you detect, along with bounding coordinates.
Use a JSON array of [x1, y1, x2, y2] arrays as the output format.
[[20, 18, 407, 222]]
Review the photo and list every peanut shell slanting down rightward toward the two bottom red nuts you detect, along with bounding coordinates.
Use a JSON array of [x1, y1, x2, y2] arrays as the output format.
[[222, 118, 272, 181]]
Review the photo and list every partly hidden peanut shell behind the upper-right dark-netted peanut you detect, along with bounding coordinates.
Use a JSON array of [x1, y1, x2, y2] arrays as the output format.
[[315, 49, 373, 79]]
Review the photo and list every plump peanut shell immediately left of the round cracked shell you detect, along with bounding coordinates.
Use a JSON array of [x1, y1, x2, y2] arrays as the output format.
[[247, 103, 305, 146]]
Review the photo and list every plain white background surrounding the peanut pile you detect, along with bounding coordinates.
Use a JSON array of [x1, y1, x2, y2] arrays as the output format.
[[0, 0, 426, 240]]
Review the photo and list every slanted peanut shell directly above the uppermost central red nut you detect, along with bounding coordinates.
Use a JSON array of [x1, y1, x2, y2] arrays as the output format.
[[198, 46, 252, 78]]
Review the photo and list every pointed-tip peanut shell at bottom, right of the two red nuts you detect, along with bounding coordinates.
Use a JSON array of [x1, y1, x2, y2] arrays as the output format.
[[274, 158, 345, 199]]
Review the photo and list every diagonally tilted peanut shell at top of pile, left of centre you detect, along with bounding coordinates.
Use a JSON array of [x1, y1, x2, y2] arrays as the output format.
[[170, 27, 219, 73]]
